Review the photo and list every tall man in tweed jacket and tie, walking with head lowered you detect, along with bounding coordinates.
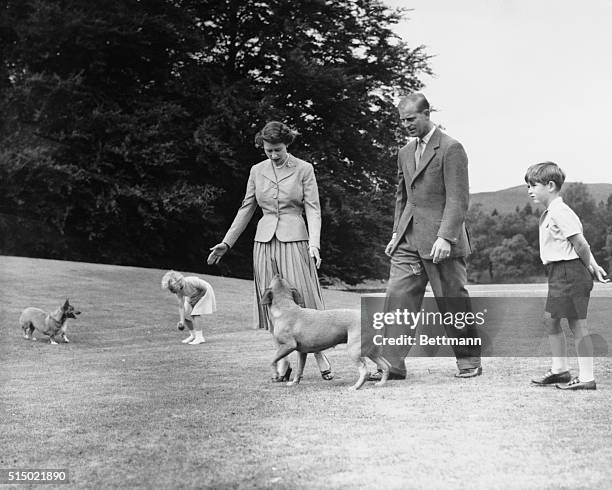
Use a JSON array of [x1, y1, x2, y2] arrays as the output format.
[[374, 93, 482, 379]]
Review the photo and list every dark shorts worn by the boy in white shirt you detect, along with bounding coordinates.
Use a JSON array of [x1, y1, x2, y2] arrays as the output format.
[[546, 259, 593, 320]]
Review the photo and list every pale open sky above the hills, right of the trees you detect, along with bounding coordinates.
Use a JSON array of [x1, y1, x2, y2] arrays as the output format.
[[384, 0, 612, 192]]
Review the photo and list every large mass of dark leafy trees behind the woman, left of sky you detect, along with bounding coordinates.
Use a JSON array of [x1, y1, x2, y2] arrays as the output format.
[[0, 0, 430, 282]]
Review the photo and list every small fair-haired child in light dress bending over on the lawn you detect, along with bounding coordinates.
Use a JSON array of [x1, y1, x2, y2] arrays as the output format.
[[162, 271, 217, 345]]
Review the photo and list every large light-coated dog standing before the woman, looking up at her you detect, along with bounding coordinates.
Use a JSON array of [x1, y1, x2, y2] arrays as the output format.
[[261, 274, 389, 390]]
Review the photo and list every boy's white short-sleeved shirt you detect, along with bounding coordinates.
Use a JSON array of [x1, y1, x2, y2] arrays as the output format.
[[540, 197, 582, 264]]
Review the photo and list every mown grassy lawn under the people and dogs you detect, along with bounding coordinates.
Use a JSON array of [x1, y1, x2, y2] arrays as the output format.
[[0, 257, 612, 489]]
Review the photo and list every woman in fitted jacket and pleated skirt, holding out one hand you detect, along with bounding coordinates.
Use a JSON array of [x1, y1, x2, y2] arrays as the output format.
[[208, 121, 333, 381]]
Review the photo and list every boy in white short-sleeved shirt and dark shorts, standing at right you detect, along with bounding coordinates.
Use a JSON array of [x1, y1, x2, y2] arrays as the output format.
[[525, 162, 608, 390]]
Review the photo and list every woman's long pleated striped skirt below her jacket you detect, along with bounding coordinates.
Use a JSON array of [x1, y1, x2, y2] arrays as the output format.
[[253, 237, 324, 331]]
